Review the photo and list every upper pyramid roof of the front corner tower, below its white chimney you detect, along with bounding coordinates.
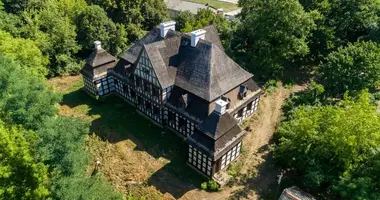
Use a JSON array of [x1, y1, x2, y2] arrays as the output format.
[[198, 111, 237, 140]]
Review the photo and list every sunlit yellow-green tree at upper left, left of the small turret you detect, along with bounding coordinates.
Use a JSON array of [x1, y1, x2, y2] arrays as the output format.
[[23, 0, 82, 76]]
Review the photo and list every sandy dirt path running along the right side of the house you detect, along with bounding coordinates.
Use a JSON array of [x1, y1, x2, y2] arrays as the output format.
[[181, 85, 306, 200]]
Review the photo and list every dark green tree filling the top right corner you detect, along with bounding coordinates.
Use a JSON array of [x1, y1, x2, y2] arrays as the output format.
[[300, 0, 380, 62]]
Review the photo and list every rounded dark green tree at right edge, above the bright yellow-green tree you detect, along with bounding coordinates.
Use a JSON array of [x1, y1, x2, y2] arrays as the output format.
[[320, 42, 380, 95]]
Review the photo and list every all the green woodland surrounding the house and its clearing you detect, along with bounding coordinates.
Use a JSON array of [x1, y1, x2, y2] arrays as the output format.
[[0, 0, 380, 200]]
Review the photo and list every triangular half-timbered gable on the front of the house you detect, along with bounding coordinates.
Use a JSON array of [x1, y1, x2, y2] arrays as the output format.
[[133, 49, 161, 88]]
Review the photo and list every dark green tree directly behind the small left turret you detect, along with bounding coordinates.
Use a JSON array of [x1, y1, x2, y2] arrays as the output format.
[[77, 5, 128, 55]]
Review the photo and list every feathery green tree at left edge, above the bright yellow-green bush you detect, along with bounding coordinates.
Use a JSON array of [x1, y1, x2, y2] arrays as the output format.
[[0, 57, 60, 130]]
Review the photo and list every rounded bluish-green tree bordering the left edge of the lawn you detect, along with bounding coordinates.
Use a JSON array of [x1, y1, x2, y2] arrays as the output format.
[[36, 116, 89, 176]]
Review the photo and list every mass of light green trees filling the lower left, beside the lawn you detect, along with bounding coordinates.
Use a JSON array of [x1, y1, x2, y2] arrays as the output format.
[[0, 57, 122, 199]]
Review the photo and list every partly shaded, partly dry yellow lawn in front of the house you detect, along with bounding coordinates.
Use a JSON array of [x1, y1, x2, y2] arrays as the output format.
[[49, 76, 205, 199]]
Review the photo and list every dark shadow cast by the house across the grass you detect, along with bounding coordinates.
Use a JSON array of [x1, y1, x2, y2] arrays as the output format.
[[62, 89, 204, 198]]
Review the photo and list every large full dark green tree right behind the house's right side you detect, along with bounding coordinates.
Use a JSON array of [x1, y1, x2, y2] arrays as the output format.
[[231, 0, 317, 78]]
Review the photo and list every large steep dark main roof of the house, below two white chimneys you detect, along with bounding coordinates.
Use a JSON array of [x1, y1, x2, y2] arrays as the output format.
[[120, 25, 253, 102]]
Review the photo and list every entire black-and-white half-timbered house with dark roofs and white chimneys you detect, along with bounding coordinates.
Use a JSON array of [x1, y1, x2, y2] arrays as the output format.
[[81, 22, 261, 181]]
